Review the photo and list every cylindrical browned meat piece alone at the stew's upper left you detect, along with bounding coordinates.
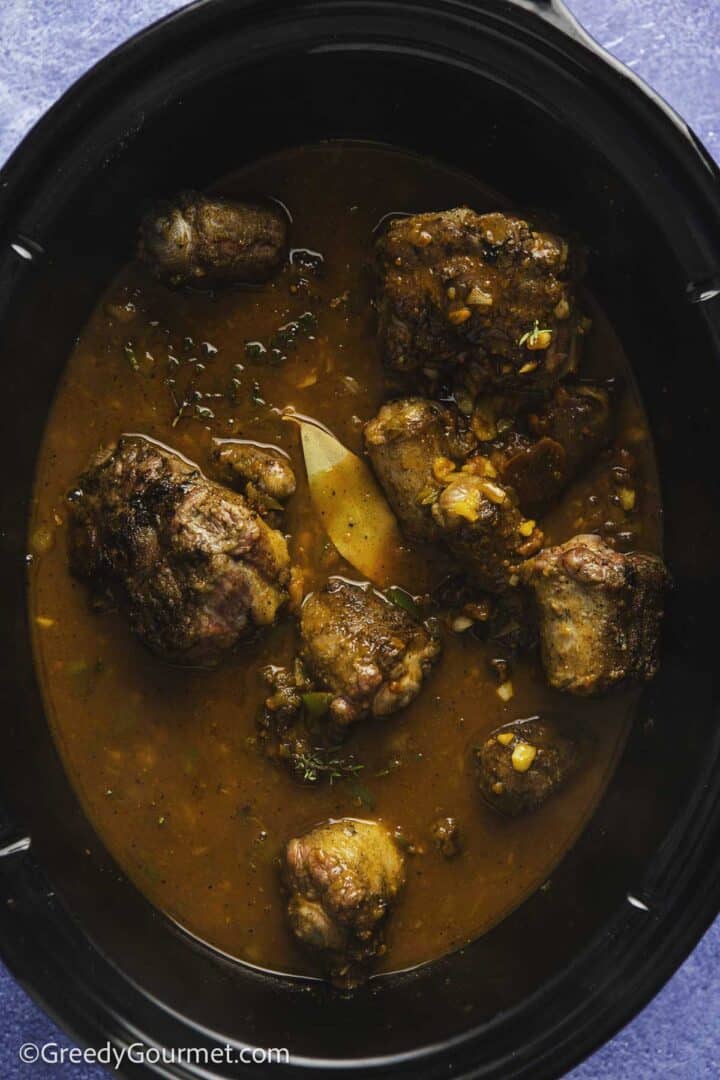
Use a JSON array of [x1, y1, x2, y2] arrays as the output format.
[[138, 191, 287, 286]]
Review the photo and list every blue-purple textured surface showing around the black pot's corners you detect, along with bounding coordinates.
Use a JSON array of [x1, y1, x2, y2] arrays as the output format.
[[0, 0, 720, 1080]]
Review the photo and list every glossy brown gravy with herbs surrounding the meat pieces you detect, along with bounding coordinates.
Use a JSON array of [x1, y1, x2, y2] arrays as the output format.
[[30, 144, 660, 973]]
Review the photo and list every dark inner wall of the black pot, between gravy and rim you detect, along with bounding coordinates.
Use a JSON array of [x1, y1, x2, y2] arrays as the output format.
[[0, 29, 720, 1075]]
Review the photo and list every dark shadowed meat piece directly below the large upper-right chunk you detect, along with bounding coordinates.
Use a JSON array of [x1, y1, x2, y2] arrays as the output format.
[[488, 386, 612, 513]]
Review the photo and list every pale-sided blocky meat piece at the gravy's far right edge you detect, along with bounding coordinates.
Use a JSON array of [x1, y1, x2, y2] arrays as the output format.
[[521, 536, 667, 694]]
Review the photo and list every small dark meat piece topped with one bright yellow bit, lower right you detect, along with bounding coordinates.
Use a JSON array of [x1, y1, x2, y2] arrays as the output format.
[[475, 717, 582, 818]]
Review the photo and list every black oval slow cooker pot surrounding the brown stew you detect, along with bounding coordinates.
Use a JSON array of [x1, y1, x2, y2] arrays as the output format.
[[0, 0, 720, 1080]]
